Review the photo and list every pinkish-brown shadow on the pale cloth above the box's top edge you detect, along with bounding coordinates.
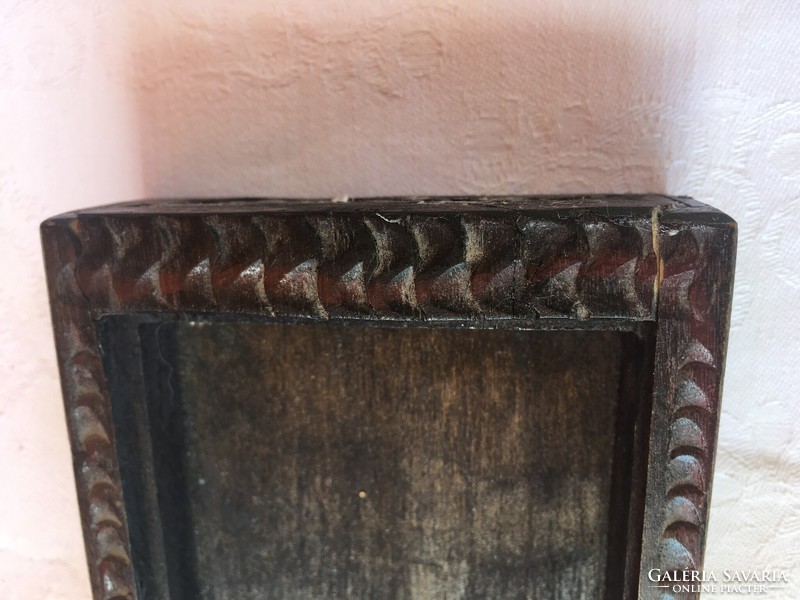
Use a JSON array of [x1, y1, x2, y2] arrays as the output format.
[[134, 6, 693, 197]]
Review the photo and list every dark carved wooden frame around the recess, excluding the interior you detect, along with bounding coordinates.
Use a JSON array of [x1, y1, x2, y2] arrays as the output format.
[[42, 196, 736, 600]]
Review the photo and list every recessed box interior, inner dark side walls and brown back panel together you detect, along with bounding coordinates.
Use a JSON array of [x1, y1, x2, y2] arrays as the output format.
[[98, 315, 652, 600]]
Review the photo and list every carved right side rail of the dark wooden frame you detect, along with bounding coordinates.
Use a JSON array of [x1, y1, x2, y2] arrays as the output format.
[[639, 213, 735, 600]]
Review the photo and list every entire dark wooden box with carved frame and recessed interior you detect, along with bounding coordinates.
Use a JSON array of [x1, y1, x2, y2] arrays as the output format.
[[42, 196, 735, 600]]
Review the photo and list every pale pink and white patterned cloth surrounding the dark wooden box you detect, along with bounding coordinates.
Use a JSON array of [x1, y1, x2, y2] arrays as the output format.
[[0, 0, 800, 600]]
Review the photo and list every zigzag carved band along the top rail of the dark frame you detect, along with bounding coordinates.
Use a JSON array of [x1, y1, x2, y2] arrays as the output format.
[[73, 213, 656, 320]]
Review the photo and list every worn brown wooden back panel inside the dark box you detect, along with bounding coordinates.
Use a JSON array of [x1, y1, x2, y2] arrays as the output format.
[[176, 324, 632, 600]]
